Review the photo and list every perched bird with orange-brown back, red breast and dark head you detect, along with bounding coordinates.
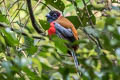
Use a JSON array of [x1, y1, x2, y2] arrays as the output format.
[[46, 10, 80, 75]]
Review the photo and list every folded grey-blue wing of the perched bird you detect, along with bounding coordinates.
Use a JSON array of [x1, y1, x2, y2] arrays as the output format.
[[54, 22, 75, 42]]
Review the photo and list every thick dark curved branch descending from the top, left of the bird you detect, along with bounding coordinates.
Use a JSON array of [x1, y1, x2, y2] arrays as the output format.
[[26, 0, 43, 33]]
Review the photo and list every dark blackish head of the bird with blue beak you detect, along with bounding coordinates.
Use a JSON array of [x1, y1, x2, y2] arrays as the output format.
[[46, 11, 61, 23]]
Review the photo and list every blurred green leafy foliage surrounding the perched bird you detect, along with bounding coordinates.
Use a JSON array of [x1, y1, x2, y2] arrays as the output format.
[[0, 0, 120, 80]]
